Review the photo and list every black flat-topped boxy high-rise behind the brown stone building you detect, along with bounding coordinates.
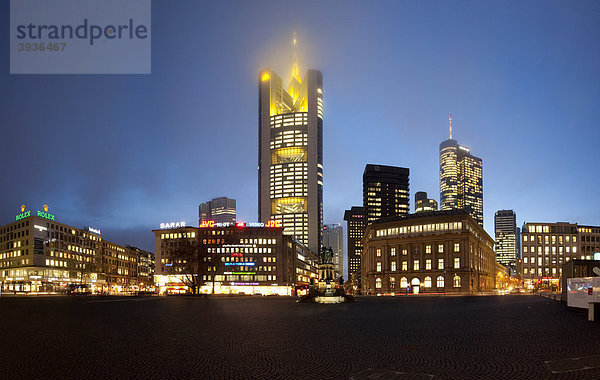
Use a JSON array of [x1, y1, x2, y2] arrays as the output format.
[[363, 164, 410, 224]]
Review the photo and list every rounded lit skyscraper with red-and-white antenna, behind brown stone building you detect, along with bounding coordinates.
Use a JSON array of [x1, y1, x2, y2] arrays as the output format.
[[440, 114, 483, 226]]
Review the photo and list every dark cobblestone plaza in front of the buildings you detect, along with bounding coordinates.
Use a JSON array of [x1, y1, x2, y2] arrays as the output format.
[[0, 295, 600, 379]]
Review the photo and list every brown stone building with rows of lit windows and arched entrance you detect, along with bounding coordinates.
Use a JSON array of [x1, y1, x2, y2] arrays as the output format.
[[361, 210, 496, 295]]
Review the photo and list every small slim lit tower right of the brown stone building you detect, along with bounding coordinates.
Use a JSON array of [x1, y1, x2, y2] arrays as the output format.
[[494, 210, 519, 269]]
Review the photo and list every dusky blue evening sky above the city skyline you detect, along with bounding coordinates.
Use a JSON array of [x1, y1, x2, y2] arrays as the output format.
[[0, 0, 600, 255]]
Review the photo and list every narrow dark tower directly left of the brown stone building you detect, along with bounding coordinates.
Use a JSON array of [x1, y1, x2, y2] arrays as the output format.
[[344, 206, 366, 291]]
